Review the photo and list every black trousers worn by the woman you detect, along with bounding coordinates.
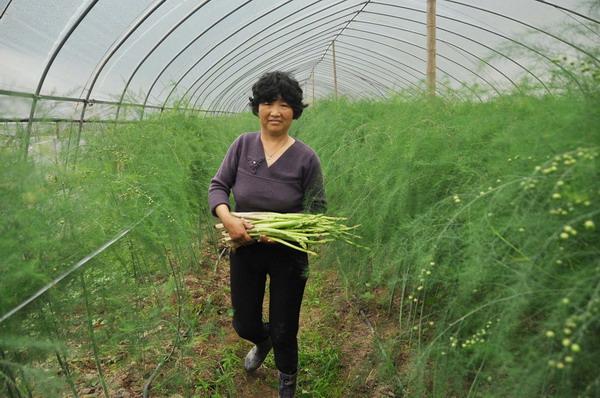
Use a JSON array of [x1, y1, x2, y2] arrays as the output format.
[[229, 243, 308, 374]]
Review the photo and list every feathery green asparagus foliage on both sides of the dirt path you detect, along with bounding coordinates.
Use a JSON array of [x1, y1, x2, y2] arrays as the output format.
[[0, 68, 600, 397]]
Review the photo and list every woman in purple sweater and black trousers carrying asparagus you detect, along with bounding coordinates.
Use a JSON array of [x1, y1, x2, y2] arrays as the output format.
[[208, 72, 326, 397]]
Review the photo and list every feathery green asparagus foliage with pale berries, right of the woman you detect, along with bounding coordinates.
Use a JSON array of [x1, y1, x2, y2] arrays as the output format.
[[297, 88, 600, 397]]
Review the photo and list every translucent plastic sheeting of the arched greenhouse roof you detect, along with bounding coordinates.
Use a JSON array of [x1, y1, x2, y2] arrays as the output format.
[[0, 0, 600, 120]]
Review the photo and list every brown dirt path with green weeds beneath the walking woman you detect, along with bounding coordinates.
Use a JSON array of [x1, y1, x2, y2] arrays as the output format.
[[70, 249, 394, 398]]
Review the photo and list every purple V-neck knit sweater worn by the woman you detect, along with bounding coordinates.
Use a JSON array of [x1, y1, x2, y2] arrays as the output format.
[[208, 133, 327, 216]]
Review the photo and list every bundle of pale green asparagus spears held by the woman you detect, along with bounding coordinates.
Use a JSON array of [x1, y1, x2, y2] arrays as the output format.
[[215, 212, 362, 256]]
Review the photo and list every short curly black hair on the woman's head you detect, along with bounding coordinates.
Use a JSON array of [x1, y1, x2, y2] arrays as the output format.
[[248, 71, 308, 119]]
